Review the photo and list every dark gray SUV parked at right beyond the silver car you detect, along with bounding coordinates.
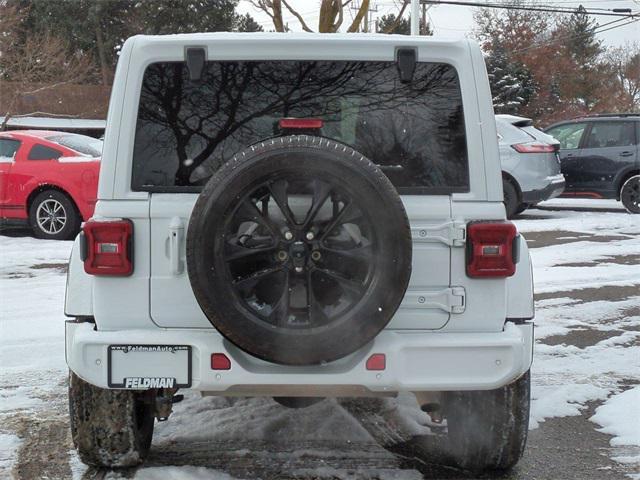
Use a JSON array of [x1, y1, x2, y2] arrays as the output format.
[[546, 113, 640, 213]]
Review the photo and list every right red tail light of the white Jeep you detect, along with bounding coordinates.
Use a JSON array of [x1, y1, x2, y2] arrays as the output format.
[[467, 222, 518, 277]]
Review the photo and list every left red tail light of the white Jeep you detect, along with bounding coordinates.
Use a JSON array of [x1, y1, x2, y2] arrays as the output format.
[[80, 220, 133, 276]]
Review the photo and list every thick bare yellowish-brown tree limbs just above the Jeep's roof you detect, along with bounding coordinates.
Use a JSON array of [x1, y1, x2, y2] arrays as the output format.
[[249, 0, 408, 33]]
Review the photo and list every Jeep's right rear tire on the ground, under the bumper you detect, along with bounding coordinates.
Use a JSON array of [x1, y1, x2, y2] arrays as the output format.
[[444, 371, 531, 473]]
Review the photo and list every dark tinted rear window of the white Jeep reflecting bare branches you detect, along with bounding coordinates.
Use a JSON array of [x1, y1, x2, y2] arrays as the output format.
[[132, 61, 469, 193]]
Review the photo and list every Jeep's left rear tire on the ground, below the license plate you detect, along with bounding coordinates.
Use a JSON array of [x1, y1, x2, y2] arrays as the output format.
[[69, 372, 155, 468]]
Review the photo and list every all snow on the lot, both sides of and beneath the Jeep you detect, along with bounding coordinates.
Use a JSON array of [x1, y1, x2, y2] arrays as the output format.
[[0, 204, 640, 480]]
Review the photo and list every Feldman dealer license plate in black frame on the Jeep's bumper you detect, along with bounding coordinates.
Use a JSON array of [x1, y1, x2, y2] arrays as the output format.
[[107, 345, 191, 390]]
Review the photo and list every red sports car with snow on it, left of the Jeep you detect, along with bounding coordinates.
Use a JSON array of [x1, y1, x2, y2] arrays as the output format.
[[0, 130, 102, 240]]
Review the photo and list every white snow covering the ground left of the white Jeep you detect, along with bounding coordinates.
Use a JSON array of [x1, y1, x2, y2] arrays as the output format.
[[0, 236, 72, 478]]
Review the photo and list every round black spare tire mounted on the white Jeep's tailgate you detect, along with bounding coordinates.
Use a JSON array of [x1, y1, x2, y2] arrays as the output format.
[[187, 136, 412, 365]]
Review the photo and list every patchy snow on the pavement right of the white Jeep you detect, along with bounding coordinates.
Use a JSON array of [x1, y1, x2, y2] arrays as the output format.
[[516, 206, 640, 468]]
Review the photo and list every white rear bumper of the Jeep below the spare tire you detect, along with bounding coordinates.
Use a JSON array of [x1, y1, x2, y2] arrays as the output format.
[[66, 321, 533, 396]]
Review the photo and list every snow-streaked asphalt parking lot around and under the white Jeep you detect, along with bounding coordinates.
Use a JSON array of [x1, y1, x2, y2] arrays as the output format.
[[0, 200, 640, 480]]
